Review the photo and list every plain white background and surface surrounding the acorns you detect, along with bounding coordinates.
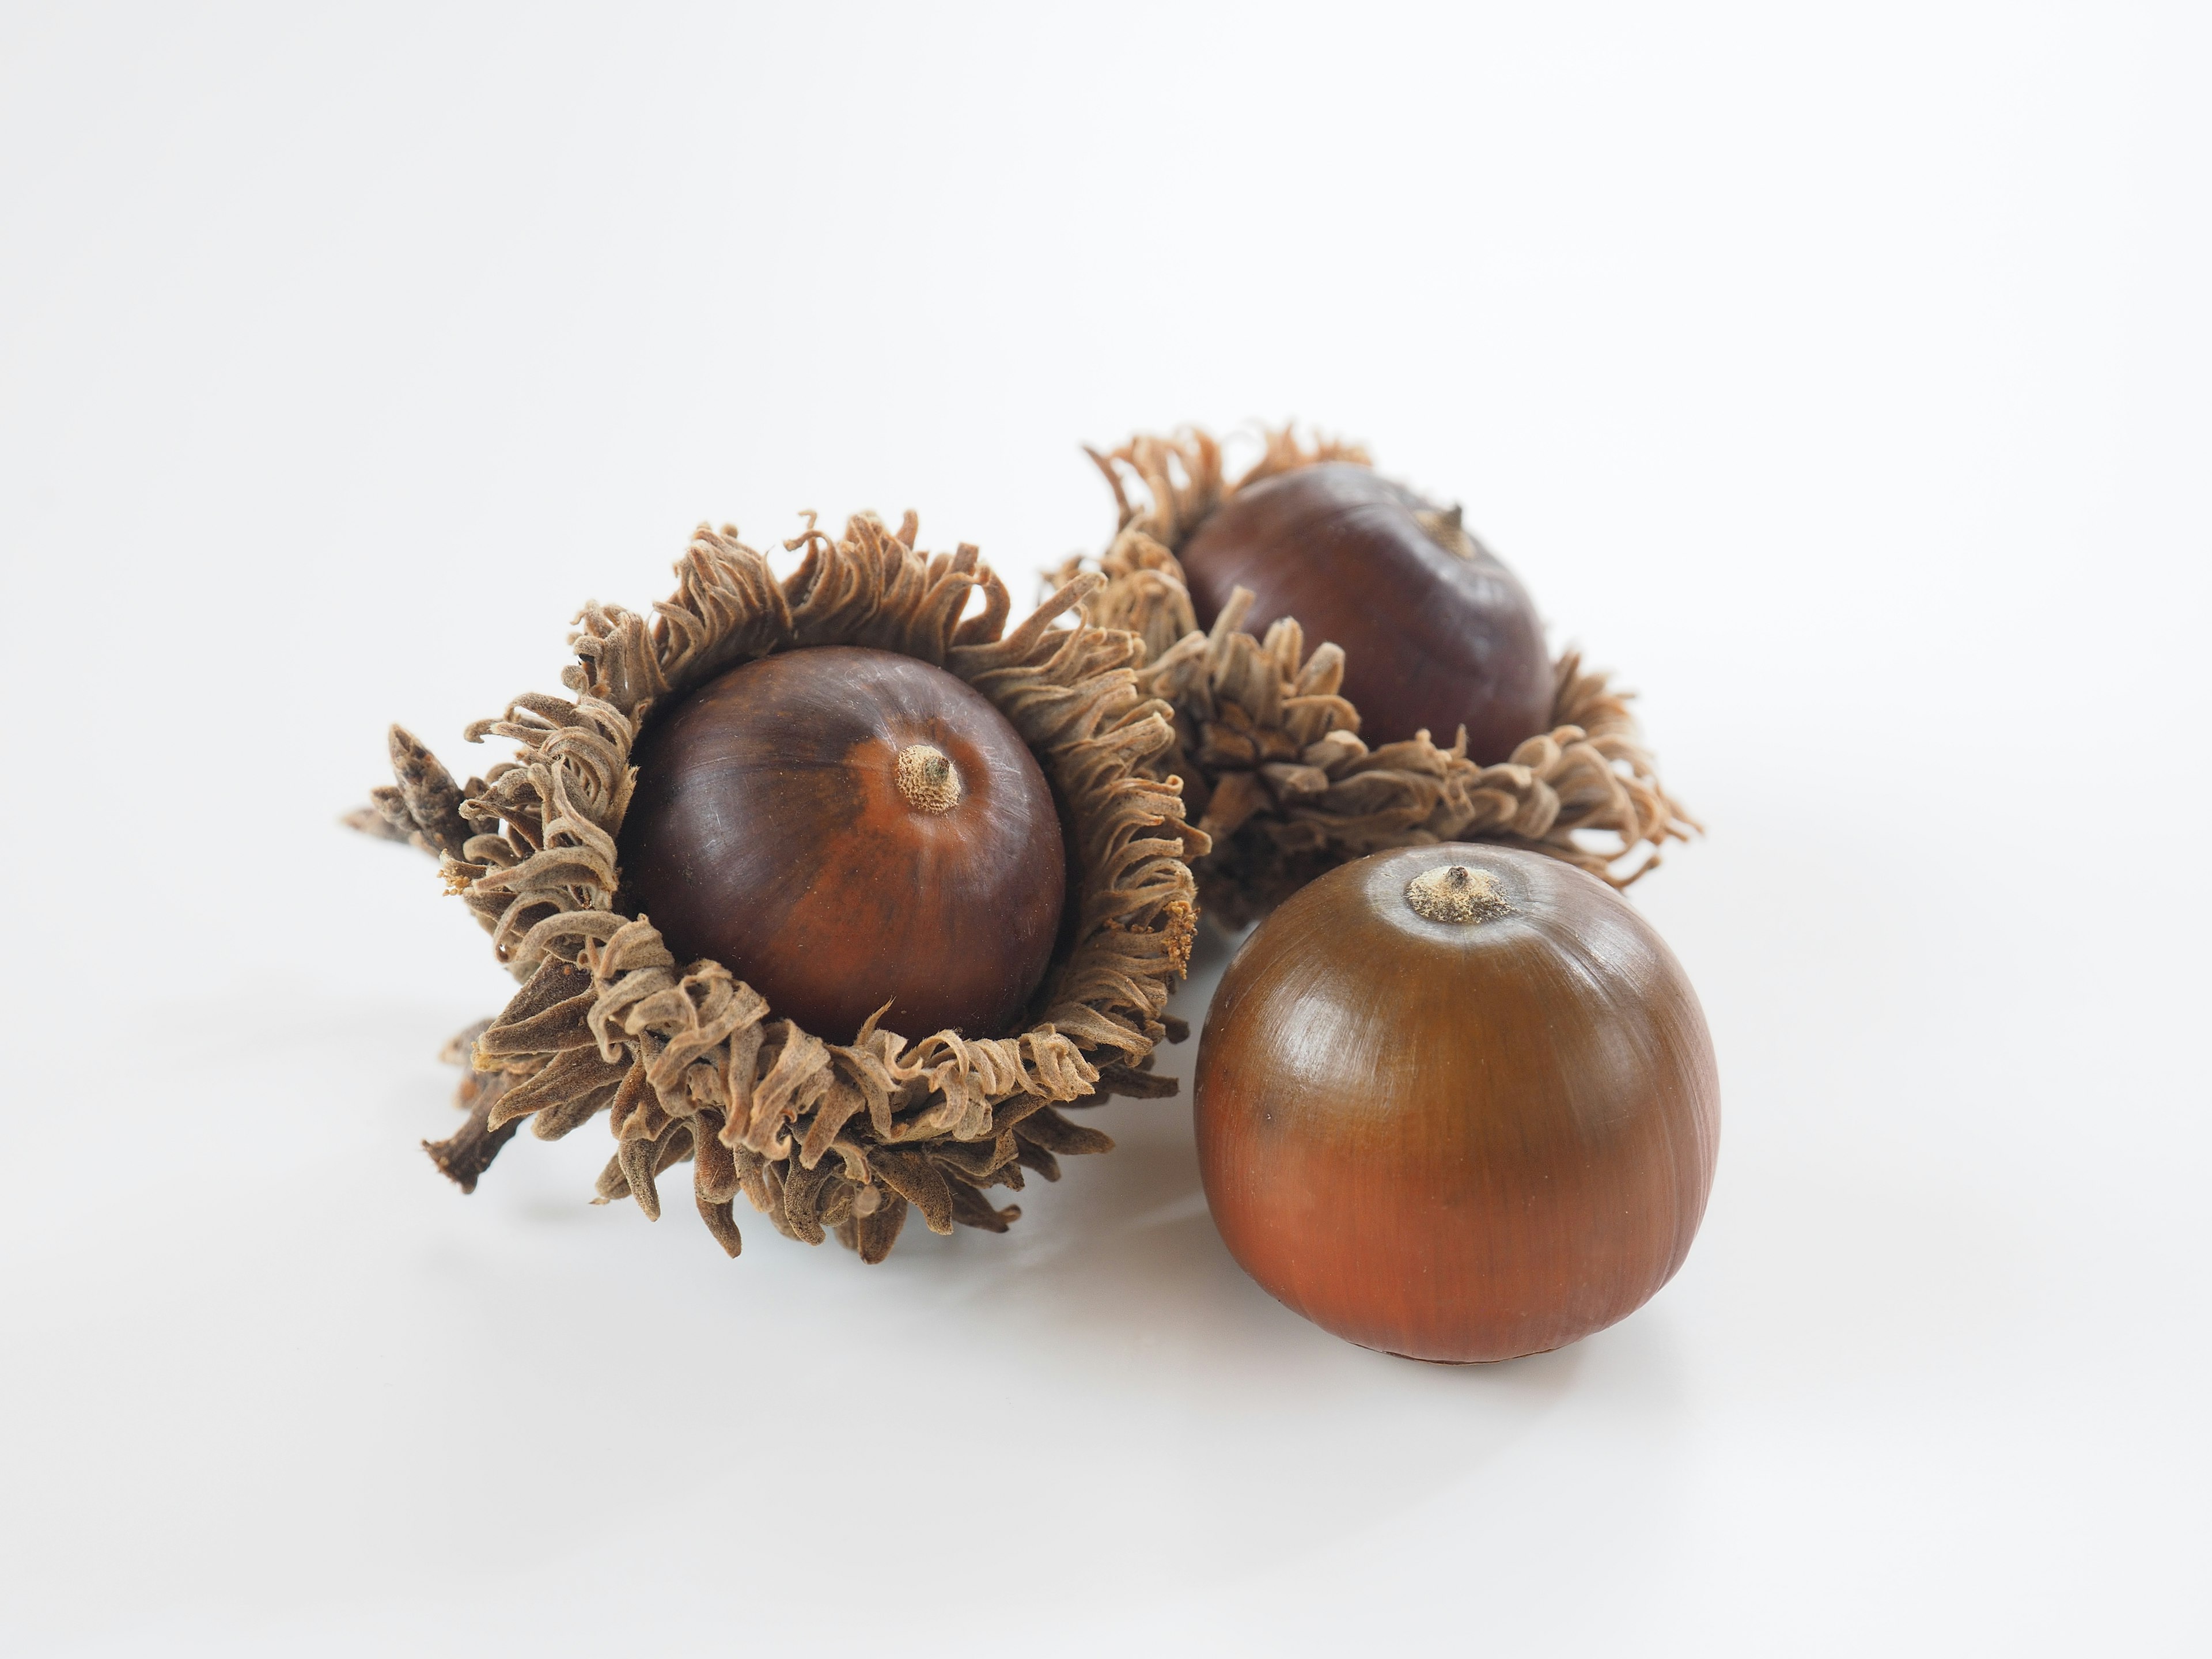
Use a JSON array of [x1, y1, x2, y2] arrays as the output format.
[[0, 0, 2212, 1654]]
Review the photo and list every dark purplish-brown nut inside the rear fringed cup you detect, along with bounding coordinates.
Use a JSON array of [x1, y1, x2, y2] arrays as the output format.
[[1177, 460, 1553, 766]]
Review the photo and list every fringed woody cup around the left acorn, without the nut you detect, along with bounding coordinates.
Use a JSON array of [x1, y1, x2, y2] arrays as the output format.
[[354, 513, 1206, 1261]]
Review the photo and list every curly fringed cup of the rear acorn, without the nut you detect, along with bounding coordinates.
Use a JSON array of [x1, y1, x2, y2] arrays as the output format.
[[1058, 427, 1696, 925]]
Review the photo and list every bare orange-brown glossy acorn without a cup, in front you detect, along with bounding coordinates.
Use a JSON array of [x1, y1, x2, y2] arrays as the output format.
[[1196, 845, 1721, 1362]]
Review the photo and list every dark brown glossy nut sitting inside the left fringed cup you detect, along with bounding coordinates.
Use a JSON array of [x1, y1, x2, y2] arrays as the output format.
[[617, 646, 1066, 1042]]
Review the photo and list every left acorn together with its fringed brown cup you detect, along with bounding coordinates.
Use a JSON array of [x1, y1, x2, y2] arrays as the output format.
[[352, 513, 1206, 1263]]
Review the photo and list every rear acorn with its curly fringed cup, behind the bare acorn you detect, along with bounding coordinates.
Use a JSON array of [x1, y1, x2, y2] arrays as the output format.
[[1058, 429, 1696, 927]]
